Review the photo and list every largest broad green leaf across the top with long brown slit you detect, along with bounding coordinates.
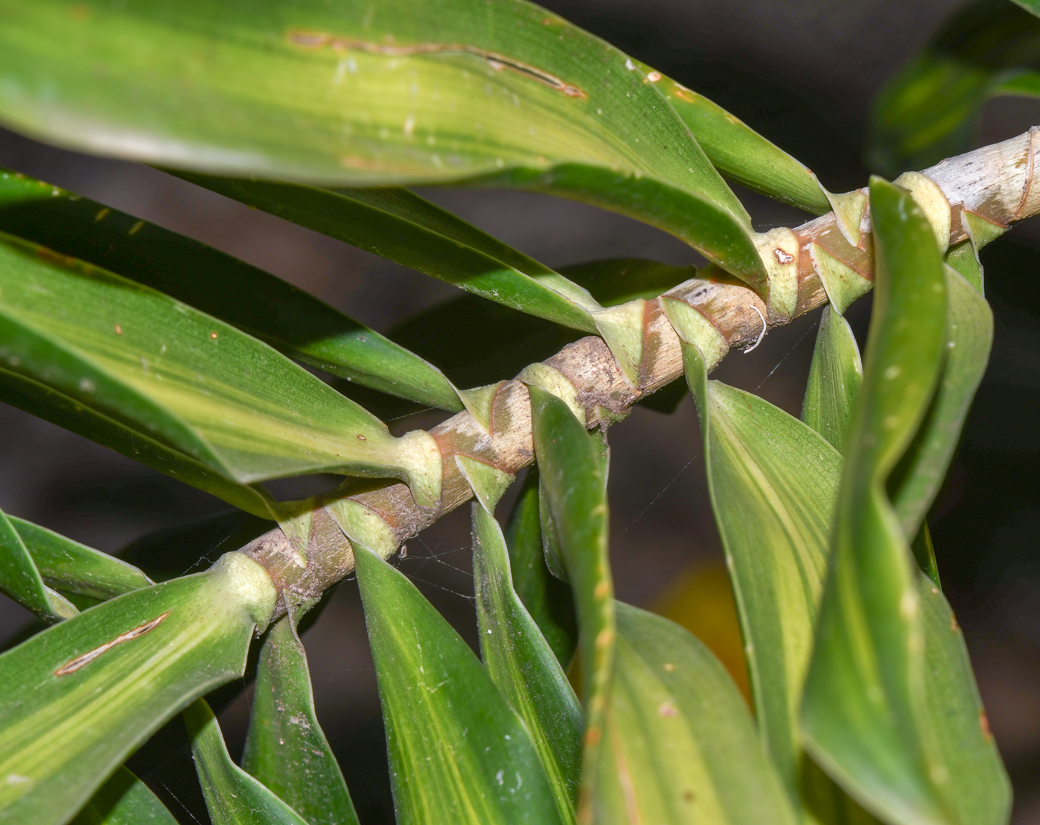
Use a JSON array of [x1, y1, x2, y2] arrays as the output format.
[[0, 0, 763, 277]]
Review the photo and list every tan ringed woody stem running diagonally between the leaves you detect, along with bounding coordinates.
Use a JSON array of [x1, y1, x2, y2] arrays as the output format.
[[244, 127, 1040, 610]]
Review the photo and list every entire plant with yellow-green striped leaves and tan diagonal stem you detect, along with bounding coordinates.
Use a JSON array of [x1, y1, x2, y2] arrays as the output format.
[[0, 0, 1040, 825]]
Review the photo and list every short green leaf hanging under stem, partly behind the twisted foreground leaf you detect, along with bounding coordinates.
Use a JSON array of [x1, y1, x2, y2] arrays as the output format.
[[802, 306, 863, 454]]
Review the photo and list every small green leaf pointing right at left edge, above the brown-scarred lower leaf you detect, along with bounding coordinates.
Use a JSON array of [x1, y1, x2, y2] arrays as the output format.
[[9, 515, 155, 599]]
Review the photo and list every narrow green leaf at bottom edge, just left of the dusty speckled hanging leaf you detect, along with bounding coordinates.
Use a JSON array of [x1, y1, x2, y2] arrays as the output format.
[[184, 699, 311, 825]]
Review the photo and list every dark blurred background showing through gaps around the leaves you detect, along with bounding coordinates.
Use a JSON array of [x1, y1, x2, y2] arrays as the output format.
[[0, 0, 1040, 825]]
